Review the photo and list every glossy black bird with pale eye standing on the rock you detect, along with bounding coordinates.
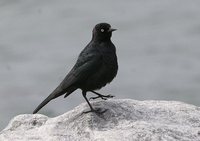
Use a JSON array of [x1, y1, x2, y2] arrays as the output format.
[[33, 23, 118, 114]]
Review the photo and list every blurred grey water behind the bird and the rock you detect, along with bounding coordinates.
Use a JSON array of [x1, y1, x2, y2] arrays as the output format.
[[0, 0, 200, 129]]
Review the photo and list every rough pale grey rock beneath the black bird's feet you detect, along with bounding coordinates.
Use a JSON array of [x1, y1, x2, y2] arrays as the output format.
[[0, 99, 200, 141]]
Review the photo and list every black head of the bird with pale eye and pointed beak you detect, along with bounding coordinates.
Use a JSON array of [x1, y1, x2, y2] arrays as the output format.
[[92, 23, 116, 41]]
